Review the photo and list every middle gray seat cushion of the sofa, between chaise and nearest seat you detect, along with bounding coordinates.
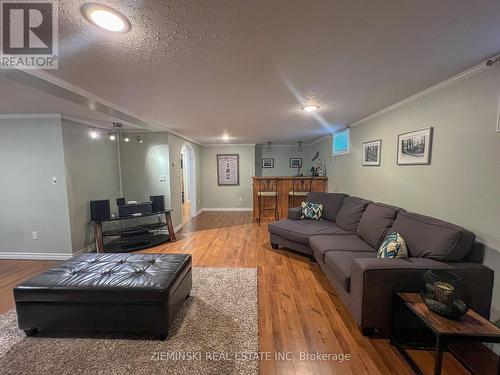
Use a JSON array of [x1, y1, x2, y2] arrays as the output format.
[[309, 233, 377, 258]]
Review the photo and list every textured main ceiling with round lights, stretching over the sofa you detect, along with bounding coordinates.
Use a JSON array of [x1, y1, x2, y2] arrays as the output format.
[[2, 0, 500, 144]]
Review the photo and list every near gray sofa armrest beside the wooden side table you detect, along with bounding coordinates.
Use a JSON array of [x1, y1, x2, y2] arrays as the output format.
[[350, 258, 493, 336]]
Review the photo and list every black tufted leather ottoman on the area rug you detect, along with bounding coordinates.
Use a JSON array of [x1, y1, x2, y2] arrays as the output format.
[[14, 254, 192, 339]]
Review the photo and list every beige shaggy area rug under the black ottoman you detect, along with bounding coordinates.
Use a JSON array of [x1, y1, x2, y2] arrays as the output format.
[[0, 268, 259, 375]]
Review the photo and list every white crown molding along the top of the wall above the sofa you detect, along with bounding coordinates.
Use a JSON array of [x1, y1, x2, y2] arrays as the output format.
[[349, 62, 490, 127]]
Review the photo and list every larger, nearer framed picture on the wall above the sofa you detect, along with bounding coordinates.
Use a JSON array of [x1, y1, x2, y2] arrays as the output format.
[[396, 127, 433, 165]]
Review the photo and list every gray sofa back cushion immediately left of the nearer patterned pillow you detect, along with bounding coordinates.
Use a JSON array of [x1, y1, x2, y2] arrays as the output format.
[[356, 203, 400, 248]]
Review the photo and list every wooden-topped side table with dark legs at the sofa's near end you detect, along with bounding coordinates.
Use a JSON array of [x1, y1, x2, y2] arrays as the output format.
[[391, 292, 500, 375]]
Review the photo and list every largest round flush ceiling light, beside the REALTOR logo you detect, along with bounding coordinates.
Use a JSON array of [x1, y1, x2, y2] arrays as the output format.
[[81, 3, 132, 33]]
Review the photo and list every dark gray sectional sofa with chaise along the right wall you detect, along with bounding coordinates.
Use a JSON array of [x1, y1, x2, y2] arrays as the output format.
[[269, 193, 493, 337]]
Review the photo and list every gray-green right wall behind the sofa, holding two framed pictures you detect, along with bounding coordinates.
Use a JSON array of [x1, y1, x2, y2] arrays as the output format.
[[328, 66, 500, 319]]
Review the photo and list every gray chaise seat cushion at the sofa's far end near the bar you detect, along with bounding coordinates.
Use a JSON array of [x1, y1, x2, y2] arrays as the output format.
[[269, 220, 344, 245]]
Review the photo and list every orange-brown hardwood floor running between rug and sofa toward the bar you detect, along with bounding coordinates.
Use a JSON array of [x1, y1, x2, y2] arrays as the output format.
[[0, 212, 469, 375]]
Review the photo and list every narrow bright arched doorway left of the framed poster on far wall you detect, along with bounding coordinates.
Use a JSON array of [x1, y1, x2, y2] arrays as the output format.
[[180, 143, 197, 225]]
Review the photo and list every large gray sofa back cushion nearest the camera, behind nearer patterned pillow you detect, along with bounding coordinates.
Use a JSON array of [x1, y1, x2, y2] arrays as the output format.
[[390, 212, 476, 261]]
